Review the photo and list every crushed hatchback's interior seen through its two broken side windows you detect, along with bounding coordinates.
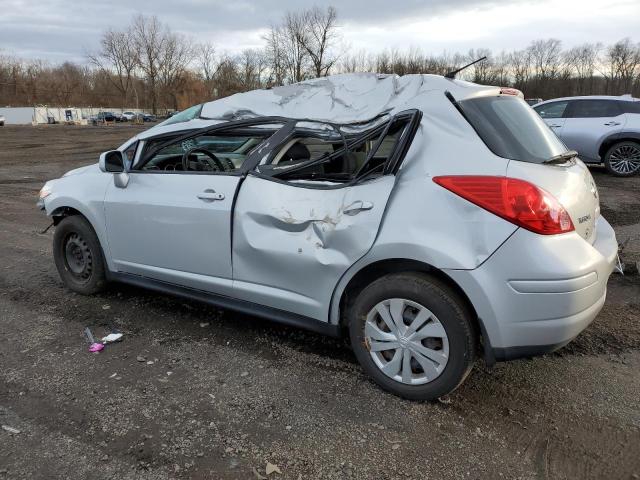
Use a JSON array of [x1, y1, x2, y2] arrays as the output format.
[[140, 117, 410, 183]]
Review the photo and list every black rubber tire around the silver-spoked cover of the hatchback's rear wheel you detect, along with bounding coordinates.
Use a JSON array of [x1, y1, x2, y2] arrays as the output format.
[[346, 273, 477, 400]]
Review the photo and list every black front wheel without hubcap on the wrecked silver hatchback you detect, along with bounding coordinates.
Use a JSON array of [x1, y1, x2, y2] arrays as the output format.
[[53, 215, 107, 295]]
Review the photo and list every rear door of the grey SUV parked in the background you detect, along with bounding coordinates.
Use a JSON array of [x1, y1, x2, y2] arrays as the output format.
[[560, 99, 626, 162]]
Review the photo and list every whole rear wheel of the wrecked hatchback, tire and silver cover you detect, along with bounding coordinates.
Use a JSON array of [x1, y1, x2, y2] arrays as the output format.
[[347, 273, 477, 400]]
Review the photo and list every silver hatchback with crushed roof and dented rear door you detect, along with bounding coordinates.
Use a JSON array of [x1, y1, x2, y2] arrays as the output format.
[[39, 74, 618, 400]]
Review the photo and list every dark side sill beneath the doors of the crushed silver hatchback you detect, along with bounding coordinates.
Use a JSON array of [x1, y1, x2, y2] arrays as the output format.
[[107, 272, 341, 337]]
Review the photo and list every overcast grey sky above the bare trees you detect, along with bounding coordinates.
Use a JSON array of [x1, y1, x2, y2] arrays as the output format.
[[0, 0, 640, 62]]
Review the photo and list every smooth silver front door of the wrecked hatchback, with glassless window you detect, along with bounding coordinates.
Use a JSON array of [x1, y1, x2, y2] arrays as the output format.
[[104, 125, 279, 294]]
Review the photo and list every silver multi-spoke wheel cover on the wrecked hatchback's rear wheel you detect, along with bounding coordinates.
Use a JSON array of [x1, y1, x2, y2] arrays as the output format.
[[364, 298, 449, 385]]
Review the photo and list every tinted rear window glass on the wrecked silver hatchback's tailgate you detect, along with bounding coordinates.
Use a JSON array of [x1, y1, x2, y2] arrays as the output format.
[[458, 96, 567, 163]]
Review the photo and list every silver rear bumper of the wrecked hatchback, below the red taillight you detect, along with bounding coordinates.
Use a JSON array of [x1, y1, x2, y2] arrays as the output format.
[[446, 217, 618, 360]]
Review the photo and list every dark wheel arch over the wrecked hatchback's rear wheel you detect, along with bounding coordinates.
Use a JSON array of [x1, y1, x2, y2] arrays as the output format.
[[331, 258, 488, 365]]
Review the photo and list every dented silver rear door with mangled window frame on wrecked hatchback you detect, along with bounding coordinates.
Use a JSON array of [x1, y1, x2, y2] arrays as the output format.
[[233, 112, 419, 321]]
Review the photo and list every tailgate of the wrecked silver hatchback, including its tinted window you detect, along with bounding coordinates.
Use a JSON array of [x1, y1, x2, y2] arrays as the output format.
[[457, 95, 600, 243]]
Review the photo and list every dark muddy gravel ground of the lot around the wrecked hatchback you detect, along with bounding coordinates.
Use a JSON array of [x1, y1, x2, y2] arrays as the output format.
[[0, 126, 640, 480]]
